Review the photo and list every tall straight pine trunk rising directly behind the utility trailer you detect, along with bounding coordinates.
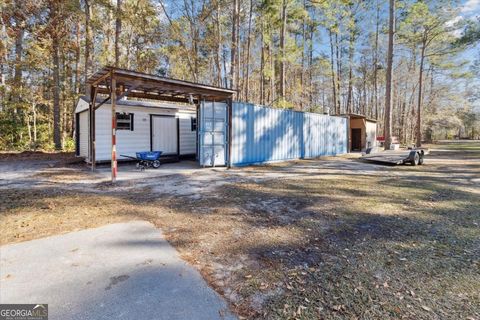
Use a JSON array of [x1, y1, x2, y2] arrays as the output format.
[[384, 0, 395, 150]]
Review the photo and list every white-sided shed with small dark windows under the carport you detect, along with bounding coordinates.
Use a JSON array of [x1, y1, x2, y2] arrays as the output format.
[[75, 97, 197, 162]]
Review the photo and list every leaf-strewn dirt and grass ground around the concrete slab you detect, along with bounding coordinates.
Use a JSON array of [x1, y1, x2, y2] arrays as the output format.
[[0, 142, 480, 319]]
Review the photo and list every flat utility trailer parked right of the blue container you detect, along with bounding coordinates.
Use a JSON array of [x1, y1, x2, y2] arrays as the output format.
[[360, 148, 429, 166]]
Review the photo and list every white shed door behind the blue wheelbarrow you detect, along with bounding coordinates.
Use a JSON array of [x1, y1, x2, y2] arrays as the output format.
[[152, 116, 178, 155]]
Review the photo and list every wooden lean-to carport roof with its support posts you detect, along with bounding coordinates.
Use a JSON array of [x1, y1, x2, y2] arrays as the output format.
[[86, 66, 235, 182]]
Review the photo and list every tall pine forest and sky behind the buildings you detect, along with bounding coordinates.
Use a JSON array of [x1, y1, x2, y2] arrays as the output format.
[[0, 0, 480, 150]]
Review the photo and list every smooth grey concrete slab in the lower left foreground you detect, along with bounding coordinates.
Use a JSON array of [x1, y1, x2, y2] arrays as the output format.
[[0, 221, 236, 319]]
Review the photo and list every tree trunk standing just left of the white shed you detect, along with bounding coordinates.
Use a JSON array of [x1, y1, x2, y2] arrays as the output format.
[[52, 32, 62, 150]]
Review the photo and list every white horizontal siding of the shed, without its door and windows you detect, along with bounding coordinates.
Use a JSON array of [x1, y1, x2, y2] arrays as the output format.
[[76, 105, 196, 161]]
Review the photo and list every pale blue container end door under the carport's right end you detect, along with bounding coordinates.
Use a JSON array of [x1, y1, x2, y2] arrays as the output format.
[[198, 101, 227, 167]]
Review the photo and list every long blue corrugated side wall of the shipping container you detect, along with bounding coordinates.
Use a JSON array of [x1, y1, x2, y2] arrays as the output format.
[[232, 102, 347, 165]]
